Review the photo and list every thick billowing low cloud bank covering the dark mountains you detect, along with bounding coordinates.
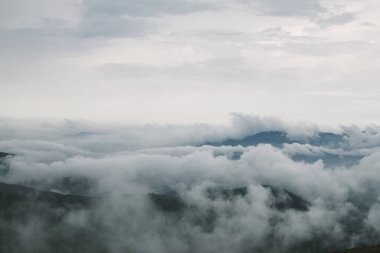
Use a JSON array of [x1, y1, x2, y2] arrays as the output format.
[[0, 114, 380, 252]]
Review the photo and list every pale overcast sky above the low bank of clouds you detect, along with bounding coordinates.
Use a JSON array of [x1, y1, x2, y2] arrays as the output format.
[[0, 0, 380, 124]]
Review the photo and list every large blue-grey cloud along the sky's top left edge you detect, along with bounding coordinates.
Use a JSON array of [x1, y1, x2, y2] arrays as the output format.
[[0, 0, 216, 47]]
